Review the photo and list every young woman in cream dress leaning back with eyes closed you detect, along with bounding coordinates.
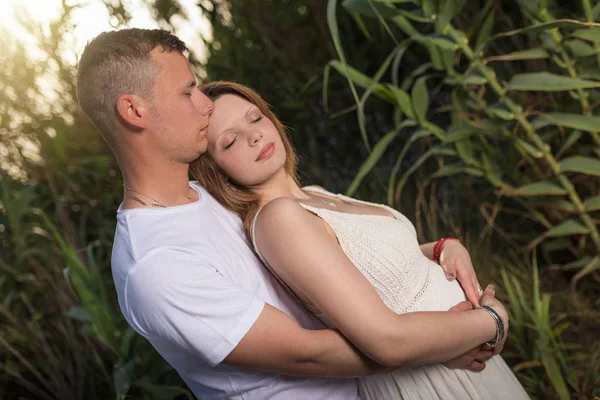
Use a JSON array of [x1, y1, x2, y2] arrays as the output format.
[[191, 82, 528, 400]]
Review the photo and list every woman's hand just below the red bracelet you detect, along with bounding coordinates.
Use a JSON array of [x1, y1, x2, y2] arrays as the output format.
[[440, 240, 481, 307]]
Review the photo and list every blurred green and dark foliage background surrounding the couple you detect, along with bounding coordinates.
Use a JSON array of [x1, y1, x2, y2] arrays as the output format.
[[0, 0, 600, 399]]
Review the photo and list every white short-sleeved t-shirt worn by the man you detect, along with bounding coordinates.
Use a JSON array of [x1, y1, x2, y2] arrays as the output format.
[[112, 182, 358, 400]]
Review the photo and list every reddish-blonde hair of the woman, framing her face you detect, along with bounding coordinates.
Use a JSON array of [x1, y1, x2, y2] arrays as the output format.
[[190, 81, 298, 241]]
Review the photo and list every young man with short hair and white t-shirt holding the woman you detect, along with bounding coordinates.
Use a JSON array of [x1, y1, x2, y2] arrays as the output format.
[[77, 29, 491, 399]]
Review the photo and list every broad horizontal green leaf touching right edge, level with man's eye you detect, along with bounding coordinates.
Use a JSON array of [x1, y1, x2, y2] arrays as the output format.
[[507, 72, 600, 92]]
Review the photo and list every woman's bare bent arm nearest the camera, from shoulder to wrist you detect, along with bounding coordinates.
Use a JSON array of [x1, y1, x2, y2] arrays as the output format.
[[256, 198, 507, 366]]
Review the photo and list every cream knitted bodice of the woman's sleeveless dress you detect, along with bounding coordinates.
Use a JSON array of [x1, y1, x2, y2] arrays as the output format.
[[252, 186, 431, 314]]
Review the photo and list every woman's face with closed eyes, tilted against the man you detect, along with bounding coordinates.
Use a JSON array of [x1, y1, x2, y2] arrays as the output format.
[[206, 94, 286, 187]]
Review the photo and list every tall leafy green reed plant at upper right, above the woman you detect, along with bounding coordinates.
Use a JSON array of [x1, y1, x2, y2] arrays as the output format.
[[324, 0, 600, 278]]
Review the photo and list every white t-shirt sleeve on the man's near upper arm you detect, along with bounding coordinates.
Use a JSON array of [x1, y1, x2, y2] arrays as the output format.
[[124, 248, 264, 366]]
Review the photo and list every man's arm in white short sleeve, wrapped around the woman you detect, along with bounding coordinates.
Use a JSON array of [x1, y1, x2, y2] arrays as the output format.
[[123, 245, 492, 377]]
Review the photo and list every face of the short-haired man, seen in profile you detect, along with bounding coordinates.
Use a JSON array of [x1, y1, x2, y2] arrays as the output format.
[[148, 47, 214, 163]]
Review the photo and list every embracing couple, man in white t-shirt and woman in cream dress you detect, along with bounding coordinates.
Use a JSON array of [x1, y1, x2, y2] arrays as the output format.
[[77, 29, 528, 400]]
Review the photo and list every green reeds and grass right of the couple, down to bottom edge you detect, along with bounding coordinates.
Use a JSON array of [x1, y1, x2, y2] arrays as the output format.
[[323, 0, 600, 399]]
